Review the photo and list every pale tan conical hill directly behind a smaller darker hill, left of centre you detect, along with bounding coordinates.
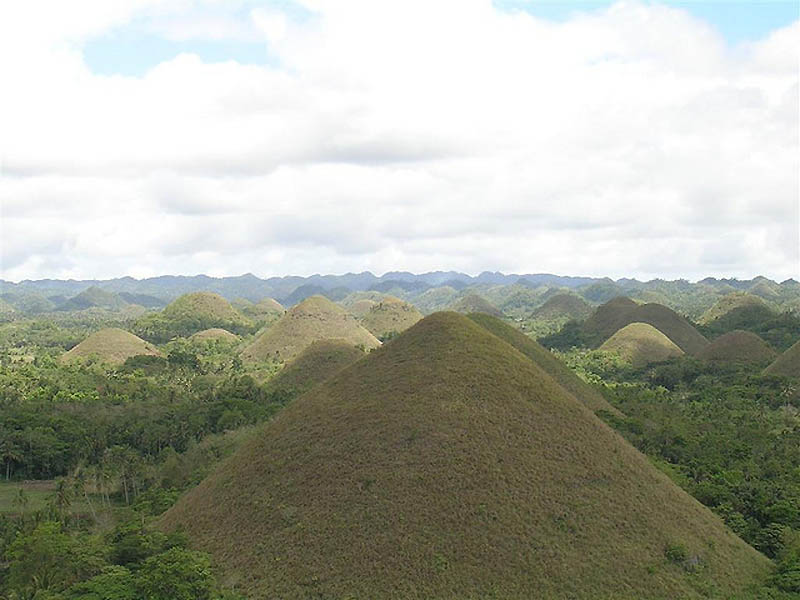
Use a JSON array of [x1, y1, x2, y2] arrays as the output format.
[[242, 296, 380, 362]]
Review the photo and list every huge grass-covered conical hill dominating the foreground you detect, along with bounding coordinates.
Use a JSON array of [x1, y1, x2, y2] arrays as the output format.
[[160, 313, 770, 600]]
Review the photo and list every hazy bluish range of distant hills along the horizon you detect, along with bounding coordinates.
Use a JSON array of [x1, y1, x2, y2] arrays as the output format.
[[0, 271, 800, 320]]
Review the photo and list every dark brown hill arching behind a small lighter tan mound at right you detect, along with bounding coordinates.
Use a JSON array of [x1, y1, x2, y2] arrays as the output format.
[[583, 298, 708, 356]]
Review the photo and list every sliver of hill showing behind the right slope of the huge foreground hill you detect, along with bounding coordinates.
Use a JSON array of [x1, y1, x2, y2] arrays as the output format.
[[468, 313, 622, 416]]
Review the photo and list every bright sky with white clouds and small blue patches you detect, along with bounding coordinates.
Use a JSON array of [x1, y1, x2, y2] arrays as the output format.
[[0, 0, 800, 281]]
